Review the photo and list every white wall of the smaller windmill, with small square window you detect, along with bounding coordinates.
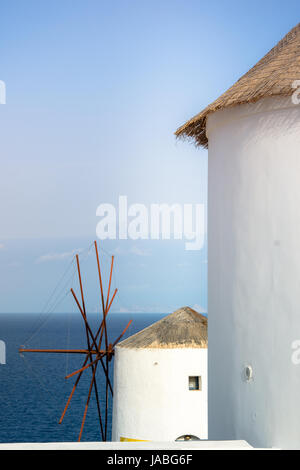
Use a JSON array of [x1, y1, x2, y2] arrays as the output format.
[[112, 347, 207, 441]]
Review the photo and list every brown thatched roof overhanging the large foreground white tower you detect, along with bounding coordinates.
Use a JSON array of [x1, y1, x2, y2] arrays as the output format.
[[175, 23, 300, 148]]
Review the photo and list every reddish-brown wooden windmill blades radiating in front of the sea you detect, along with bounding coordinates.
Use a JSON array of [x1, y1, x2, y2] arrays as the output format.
[[19, 241, 131, 441]]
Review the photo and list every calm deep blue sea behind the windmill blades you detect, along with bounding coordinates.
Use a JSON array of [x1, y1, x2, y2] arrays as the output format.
[[0, 313, 164, 442]]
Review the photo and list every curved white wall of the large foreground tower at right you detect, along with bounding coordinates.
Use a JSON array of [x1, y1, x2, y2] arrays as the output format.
[[207, 94, 300, 448]]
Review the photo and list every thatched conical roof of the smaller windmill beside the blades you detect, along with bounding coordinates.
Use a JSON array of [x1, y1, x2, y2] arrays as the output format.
[[118, 307, 207, 349]]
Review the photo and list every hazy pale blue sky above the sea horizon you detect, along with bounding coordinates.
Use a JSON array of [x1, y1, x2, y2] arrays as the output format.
[[0, 0, 300, 312]]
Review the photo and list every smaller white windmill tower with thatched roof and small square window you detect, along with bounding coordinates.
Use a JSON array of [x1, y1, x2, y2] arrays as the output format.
[[112, 307, 207, 441]]
